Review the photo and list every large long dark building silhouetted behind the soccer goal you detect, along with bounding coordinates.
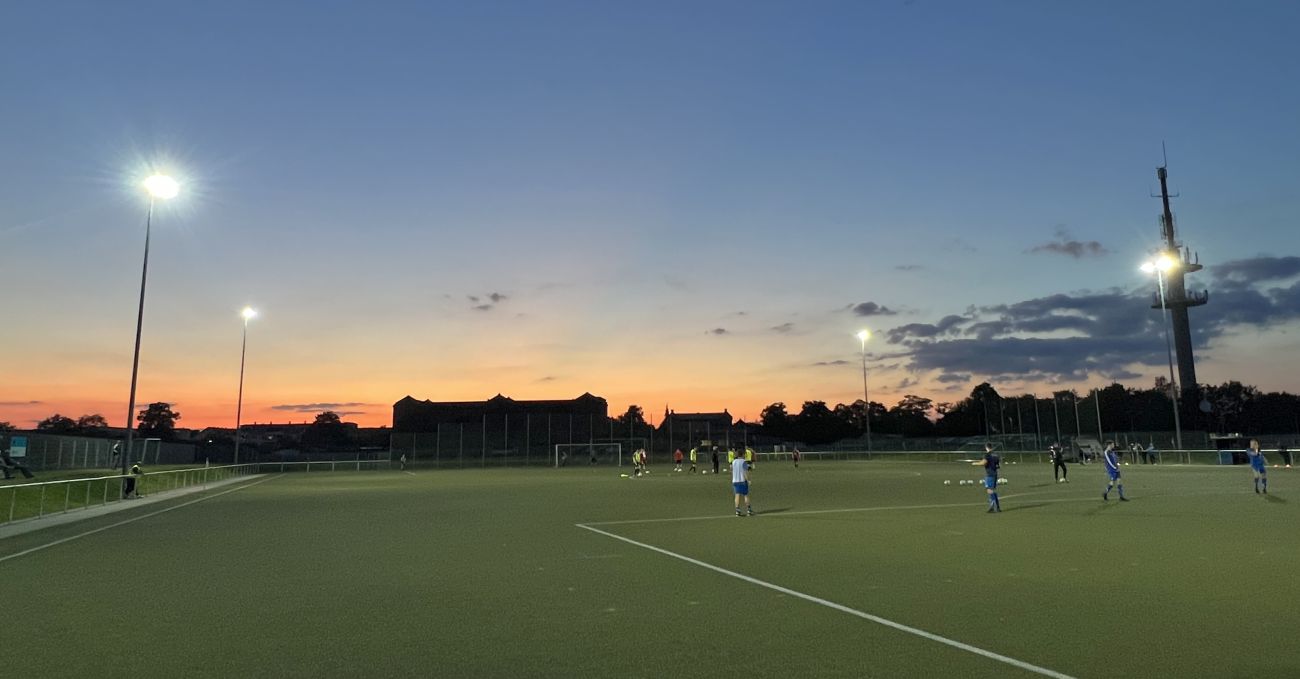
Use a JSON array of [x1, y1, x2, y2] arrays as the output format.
[[393, 393, 610, 438]]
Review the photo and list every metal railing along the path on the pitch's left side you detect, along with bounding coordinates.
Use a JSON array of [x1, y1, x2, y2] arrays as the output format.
[[0, 459, 391, 526]]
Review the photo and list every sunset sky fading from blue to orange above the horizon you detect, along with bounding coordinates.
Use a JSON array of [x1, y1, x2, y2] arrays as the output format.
[[0, 0, 1300, 427]]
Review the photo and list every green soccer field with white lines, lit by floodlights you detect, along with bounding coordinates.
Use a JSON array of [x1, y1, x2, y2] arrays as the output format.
[[0, 462, 1300, 679]]
